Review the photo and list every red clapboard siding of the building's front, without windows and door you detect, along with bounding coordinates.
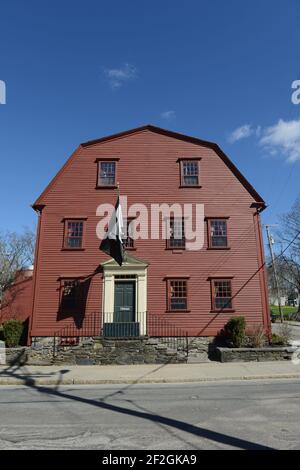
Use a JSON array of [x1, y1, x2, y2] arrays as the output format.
[[31, 129, 269, 336]]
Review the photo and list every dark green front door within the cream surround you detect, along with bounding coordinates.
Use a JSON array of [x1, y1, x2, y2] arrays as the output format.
[[114, 281, 135, 323]]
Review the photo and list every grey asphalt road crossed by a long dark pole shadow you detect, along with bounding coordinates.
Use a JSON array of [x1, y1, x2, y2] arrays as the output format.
[[0, 380, 300, 450]]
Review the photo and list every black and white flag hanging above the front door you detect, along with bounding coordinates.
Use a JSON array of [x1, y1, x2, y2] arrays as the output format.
[[100, 196, 124, 266]]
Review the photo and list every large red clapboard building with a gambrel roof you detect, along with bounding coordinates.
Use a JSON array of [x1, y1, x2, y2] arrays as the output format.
[[30, 125, 269, 344]]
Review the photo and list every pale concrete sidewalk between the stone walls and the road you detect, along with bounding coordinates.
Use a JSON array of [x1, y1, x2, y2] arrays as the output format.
[[0, 361, 300, 386]]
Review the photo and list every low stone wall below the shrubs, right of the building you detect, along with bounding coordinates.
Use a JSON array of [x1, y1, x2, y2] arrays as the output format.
[[216, 347, 296, 362]]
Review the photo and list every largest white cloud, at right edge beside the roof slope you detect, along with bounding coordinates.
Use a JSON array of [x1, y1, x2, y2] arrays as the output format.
[[259, 119, 300, 163]]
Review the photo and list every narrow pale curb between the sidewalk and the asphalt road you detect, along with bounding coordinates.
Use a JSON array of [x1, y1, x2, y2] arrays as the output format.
[[0, 373, 300, 387]]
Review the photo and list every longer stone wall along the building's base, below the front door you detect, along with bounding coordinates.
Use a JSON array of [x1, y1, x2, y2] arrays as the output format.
[[6, 337, 213, 365]]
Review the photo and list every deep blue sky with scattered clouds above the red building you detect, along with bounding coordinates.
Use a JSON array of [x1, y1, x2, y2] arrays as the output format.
[[0, 0, 300, 242]]
